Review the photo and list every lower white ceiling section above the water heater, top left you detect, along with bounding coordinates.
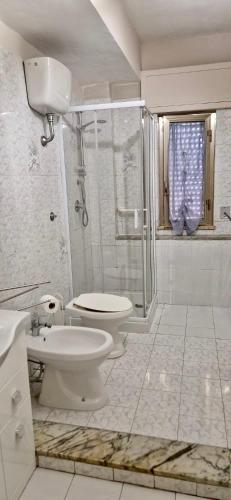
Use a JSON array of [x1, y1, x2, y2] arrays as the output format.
[[0, 0, 137, 83]]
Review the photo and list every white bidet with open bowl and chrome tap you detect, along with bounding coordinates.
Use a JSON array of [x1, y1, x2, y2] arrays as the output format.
[[27, 326, 113, 410]]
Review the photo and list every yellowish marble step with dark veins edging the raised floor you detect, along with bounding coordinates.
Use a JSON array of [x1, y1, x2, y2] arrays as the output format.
[[34, 420, 231, 500]]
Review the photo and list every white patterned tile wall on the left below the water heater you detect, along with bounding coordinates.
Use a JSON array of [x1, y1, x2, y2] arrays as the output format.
[[0, 49, 73, 307]]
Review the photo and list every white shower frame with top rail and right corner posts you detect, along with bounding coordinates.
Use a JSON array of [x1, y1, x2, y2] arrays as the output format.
[[68, 100, 156, 319]]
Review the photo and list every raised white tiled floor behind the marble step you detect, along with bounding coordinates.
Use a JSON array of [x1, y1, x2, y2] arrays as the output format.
[[33, 305, 231, 447]]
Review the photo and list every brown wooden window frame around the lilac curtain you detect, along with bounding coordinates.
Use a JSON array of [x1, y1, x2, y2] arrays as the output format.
[[159, 112, 216, 229]]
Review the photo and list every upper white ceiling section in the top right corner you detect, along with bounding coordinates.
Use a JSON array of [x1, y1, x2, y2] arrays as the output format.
[[122, 0, 231, 42]]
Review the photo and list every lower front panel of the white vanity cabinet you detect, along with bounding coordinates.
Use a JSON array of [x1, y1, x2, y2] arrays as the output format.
[[0, 398, 35, 500]]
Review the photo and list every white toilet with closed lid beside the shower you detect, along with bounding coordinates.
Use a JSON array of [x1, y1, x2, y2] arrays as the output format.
[[66, 293, 133, 358]]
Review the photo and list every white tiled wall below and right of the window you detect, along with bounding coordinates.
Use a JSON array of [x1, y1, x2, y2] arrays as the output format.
[[156, 109, 231, 307]]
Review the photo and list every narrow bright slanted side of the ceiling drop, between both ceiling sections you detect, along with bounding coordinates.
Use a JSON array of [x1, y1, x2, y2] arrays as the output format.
[[91, 0, 141, 79]]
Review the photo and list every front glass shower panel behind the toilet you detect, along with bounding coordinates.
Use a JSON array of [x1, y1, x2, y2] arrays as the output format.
[[82, 108, 144, 316]]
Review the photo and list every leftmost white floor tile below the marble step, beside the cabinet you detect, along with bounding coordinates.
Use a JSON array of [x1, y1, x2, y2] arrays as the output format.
[[20, 468, 73, 500]]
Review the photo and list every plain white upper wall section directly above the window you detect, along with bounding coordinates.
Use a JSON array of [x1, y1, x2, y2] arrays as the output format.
[[141, 62, 231, 113]]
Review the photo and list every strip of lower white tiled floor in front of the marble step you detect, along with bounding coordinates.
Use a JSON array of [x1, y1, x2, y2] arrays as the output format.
[[20, 468, 209, 500]]
